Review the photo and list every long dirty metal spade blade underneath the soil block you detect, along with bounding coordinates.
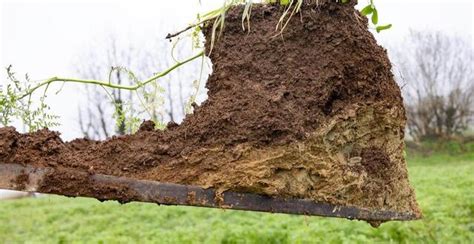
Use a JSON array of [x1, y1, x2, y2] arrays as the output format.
[[0, 163, 419, 221]]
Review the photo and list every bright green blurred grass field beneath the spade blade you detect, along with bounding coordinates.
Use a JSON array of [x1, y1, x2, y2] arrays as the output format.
[[0, 154, 474, 243]]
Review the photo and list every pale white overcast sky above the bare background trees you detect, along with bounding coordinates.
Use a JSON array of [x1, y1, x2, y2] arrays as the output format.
[[0, 0, 474, 140]]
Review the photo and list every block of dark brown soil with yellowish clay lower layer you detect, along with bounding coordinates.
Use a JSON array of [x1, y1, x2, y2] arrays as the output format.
[[0, 1, 420, 219]]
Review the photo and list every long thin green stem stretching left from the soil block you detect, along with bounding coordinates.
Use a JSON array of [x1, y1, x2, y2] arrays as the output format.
[[19, 51, 204, 99]]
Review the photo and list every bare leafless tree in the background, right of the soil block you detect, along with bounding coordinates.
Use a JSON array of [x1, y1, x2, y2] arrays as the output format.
[[396, 31, 474, 141]]
